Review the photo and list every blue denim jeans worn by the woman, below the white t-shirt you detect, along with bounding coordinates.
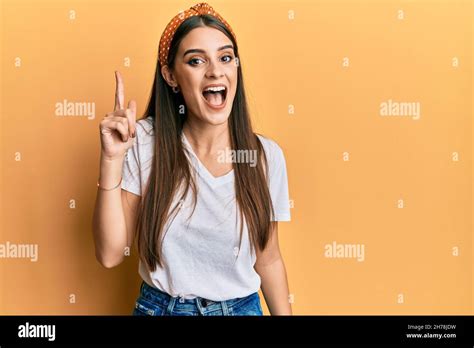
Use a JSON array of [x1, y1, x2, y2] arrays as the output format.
[[132, 281, 263, 316]]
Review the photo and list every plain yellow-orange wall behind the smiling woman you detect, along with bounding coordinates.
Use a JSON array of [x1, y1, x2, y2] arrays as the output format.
[[0, 0, 474, 315]]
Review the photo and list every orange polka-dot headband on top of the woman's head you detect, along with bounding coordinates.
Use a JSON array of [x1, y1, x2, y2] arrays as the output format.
[[159, 2, 236, 66]]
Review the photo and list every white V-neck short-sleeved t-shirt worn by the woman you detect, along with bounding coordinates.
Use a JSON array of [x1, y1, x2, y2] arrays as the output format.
[[122, 117, 290, 301]]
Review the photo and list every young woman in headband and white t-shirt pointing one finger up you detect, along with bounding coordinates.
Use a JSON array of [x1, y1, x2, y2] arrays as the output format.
[[93, 3, 291, 315]]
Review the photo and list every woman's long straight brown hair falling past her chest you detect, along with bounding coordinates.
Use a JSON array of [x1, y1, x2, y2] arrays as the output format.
[[136, 15, 274, 271]]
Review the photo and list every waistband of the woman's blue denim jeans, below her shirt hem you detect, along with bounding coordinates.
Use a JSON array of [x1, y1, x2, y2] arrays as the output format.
[[140, 281, 260, 314]]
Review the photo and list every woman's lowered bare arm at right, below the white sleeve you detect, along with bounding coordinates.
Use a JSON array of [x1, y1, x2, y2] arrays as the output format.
[[254, 221, 292, 315]]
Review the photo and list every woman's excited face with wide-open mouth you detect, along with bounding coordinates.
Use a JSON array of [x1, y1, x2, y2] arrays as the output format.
[[165, 27, 237, 125]]
